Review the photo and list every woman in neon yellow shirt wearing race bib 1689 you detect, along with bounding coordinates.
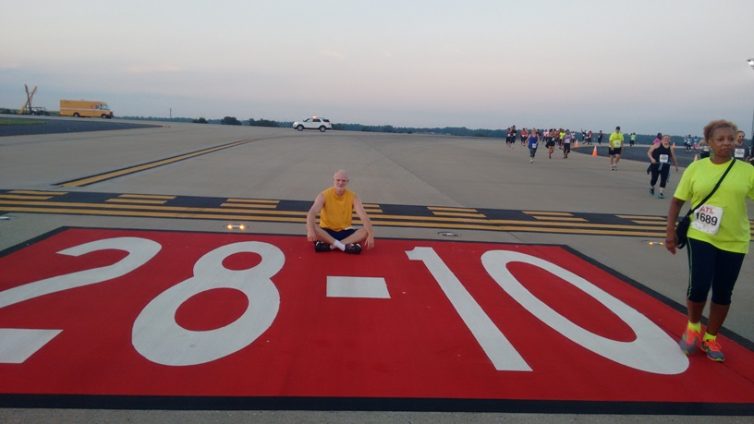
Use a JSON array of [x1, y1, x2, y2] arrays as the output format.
[[665, 120, 754, 362]]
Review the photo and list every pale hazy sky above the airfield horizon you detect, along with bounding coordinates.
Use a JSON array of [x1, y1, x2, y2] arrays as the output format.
[[0, 0, 754, 138]]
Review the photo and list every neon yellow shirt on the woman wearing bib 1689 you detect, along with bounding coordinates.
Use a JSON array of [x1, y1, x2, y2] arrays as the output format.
[[673, 158, 754, 253]]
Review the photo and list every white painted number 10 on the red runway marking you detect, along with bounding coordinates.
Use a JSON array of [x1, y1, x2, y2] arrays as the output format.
[[406, 247, 689, 375]]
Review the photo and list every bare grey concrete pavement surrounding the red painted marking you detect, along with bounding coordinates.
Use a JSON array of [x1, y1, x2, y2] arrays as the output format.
[[0, 120, 754, 423]]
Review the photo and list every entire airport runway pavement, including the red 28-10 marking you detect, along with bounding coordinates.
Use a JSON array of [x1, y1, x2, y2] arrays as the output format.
[[0, 115, 754, 423]]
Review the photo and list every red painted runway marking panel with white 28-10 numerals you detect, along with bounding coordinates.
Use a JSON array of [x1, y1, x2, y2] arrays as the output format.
[[0, 229, 754, 404]]
